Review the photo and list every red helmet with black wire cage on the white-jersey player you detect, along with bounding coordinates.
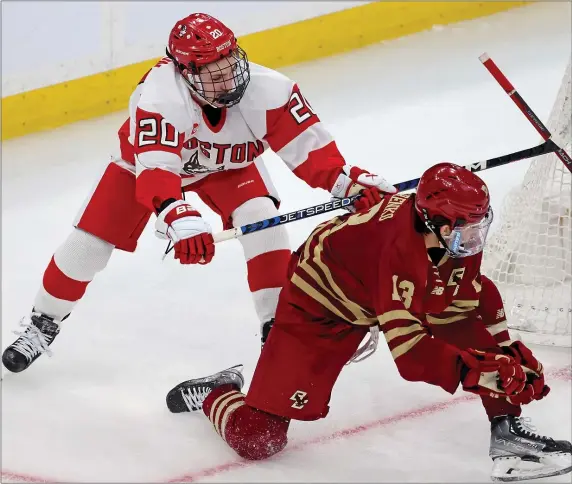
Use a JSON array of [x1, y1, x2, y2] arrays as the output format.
[[167, 13, 250, 108]]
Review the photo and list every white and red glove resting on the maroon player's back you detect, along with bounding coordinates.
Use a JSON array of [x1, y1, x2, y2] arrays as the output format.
[[330, 165, 397, 211]]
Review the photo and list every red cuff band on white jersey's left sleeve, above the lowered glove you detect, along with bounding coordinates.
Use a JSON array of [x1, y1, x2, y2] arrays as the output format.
[[135, 168, 181, 212]]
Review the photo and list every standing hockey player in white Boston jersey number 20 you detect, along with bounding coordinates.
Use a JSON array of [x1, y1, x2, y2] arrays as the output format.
[[2, 13, 395, 372]]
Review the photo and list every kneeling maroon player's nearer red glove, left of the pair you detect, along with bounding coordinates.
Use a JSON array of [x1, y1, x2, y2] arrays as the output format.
[[461, 349, 526, 398]]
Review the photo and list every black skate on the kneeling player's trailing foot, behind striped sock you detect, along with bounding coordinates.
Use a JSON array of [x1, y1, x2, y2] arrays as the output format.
[[167, 365, 244, 413]]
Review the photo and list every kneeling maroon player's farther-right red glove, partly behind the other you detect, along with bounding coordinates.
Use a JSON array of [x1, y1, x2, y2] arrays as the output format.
[[501, 341, 550, 405]]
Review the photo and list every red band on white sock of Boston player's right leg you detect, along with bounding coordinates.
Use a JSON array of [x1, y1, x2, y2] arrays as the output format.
[[246, 249, 292, 292]]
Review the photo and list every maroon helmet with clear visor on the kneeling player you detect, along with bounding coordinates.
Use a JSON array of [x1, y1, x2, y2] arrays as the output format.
[[415, 163, 493, 257]]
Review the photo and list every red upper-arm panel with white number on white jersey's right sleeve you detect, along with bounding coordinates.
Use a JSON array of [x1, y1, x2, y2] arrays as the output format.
[[264, 84, 320, 152]]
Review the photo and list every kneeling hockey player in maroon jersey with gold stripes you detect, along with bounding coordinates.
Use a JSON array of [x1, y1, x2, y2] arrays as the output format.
[[167, 163, 572, 480]]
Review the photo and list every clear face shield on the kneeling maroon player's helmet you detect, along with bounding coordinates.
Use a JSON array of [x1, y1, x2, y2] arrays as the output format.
[[425, 207, 493, 258]]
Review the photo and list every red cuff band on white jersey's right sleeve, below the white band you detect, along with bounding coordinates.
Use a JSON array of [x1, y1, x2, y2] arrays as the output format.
[[294, 141, 346, 191]]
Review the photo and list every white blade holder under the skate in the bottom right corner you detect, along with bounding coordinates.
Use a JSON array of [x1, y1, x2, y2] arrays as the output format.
[[491, 454, 572, 482]]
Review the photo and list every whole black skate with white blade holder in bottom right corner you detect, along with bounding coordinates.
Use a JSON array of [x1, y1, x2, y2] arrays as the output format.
[[489, 415, 572, 482]]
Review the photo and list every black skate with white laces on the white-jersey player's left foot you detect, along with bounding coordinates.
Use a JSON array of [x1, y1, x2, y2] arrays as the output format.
[[2, 312, 60, 373]]
